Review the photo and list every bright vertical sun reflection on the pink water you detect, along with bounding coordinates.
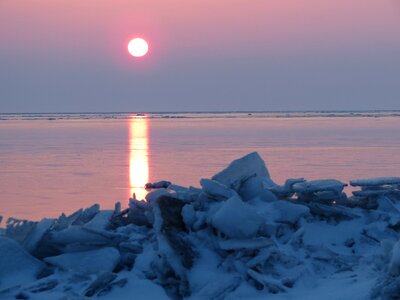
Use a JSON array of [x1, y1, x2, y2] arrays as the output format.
[[129, 117, 149, 200]]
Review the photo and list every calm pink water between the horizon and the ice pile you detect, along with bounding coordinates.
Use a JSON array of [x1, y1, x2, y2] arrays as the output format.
[[0, 112, 400, 219]]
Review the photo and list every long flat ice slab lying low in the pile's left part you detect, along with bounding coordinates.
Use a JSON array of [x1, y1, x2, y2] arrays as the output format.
[[44, 247, 120, 274]]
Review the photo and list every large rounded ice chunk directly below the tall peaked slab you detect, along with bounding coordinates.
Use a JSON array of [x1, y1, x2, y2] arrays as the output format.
[[212, 195, 264, 238]]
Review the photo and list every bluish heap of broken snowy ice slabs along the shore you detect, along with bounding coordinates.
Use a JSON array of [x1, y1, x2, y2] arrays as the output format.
[[0, 153, 400, 299]]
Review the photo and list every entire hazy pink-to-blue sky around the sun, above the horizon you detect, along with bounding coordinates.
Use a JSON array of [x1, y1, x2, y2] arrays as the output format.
[[0, 0, 400, 113]]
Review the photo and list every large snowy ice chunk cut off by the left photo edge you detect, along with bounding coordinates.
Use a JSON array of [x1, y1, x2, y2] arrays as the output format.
[[0, 237, 45, 289]]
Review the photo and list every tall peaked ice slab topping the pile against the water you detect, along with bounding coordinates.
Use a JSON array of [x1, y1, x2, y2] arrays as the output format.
[[212, 152, 270, 191]]
